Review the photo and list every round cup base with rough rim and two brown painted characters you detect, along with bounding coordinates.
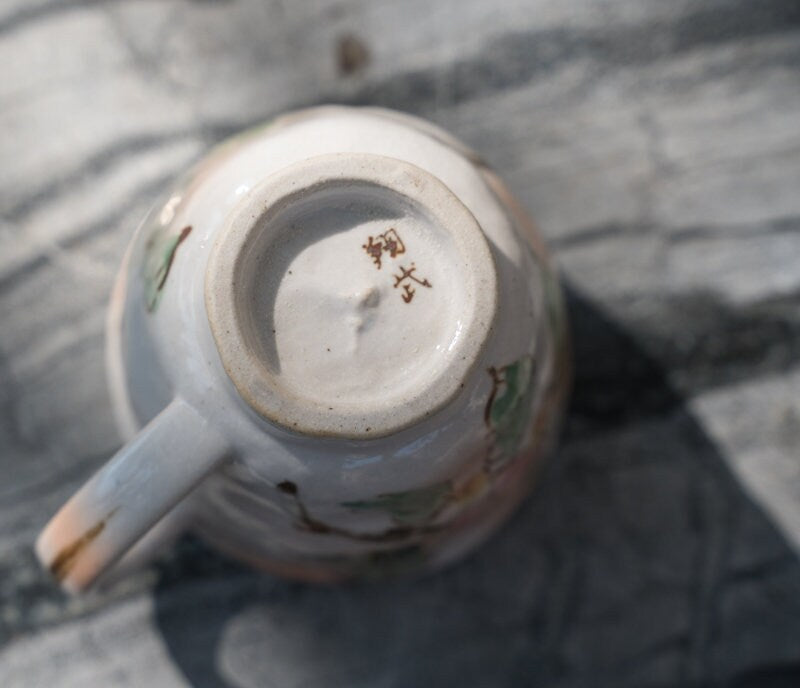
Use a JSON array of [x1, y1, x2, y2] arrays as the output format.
[[205, 154, 497, 440]]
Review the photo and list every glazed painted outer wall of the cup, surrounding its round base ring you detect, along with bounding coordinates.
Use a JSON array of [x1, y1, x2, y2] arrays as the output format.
[[40, 107, 569, 589]]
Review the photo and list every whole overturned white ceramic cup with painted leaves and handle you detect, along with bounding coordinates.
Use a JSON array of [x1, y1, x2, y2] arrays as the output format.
[[37, 107, 568, 590]]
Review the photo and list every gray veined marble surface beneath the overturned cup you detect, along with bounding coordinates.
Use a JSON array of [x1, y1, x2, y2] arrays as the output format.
[[0, 0, 800, 688]]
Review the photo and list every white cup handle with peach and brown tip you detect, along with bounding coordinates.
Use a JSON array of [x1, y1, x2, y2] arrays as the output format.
[[36, 398, 231, 593]]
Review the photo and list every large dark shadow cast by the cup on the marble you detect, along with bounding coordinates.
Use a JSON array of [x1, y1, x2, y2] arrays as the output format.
[[155, 289, 800, 688]]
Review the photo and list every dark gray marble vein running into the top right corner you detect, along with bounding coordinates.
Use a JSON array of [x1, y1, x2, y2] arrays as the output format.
[[324, 0, 800, 111]]
